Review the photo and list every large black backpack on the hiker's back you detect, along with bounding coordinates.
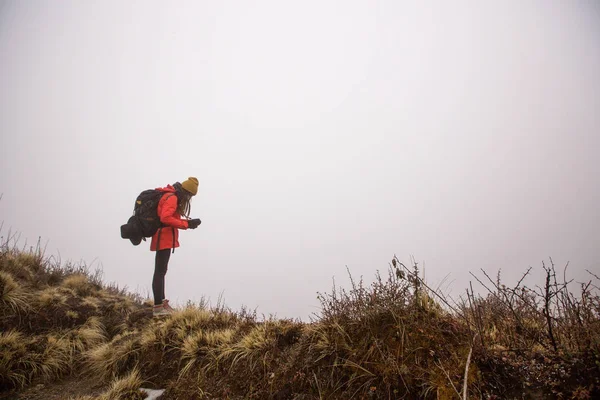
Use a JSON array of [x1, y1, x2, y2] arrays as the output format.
[[121, 189, 171, 246]]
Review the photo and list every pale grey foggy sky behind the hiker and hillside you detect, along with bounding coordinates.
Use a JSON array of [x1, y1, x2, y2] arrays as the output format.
[[0, 0, 600, 318]]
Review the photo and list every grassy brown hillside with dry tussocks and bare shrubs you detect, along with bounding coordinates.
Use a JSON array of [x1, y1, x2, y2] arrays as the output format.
[[0, 244, 600, 400]]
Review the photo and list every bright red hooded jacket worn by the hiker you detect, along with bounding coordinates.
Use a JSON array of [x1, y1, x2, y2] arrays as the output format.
[[150, 185, 188, 251]]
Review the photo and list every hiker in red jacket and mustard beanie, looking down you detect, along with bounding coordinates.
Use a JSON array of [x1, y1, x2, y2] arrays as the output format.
[[150, 177, 200, 315]]
